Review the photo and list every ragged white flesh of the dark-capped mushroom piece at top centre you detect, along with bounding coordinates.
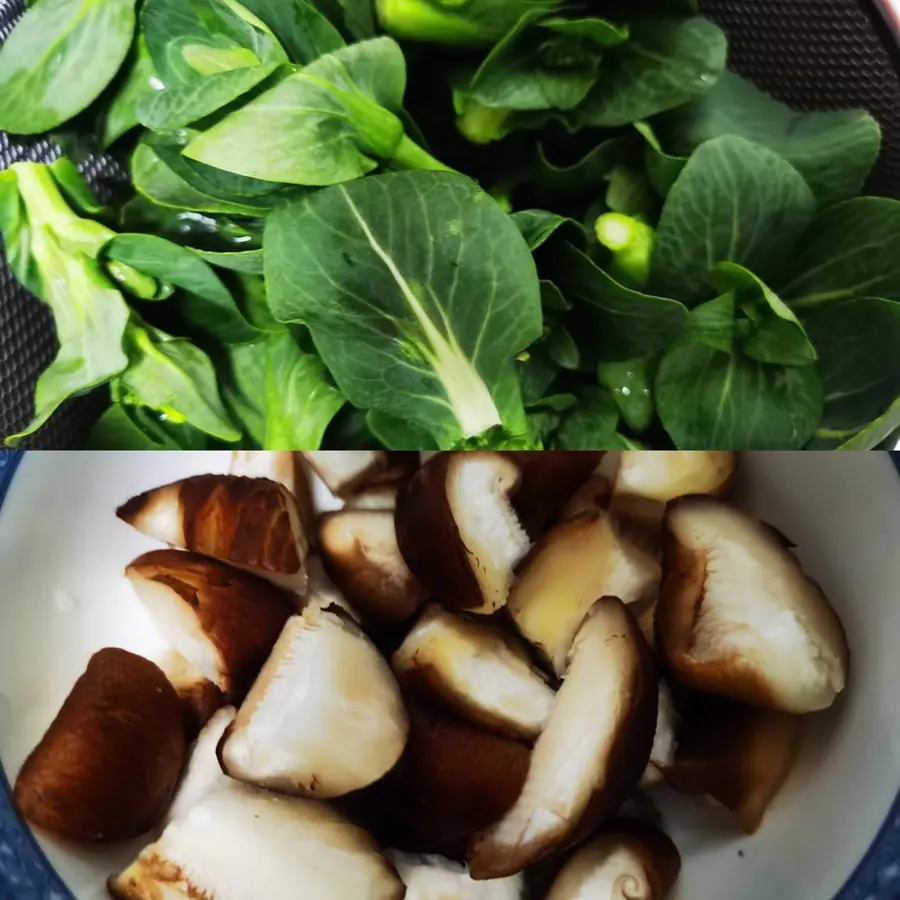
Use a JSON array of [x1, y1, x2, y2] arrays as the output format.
[[446, 454, 531, 613]]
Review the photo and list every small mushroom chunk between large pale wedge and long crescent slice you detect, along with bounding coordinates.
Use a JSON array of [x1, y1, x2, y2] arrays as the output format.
[[391, 604, 556, 740]]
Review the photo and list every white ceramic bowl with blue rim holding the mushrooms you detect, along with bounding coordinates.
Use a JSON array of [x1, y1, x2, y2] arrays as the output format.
[[0, 452, 900, 900]]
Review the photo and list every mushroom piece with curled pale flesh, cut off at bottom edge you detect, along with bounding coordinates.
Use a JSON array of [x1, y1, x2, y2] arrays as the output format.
[[547, 819, 681, 900]]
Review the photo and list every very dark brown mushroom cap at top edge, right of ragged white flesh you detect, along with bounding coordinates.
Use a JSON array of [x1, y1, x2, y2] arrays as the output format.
[[508, 450, 604, 538]]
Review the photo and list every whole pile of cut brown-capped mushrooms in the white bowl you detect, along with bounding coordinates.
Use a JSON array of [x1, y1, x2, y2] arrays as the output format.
[[15, 451, 848, 900]]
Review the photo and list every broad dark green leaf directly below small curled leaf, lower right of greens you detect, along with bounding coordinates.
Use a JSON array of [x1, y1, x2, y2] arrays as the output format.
[[656, 337, 822, 450]]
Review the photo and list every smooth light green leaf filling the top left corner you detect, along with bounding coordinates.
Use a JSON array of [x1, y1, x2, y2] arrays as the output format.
[[0, 0, 135, 134]]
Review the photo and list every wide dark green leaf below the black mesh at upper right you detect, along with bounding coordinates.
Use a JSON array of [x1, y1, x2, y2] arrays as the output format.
[[654, 72, 881, 206]]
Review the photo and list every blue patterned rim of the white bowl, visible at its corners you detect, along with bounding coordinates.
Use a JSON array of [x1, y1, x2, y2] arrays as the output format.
[[0, 450, 900, 900]]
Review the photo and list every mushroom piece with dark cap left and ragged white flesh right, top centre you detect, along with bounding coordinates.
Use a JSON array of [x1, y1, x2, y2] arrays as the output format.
[[396, 452, 531, 614]]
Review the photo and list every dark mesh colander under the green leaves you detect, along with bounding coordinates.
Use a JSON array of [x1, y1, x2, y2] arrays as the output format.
[[0, 0, 900, 448]]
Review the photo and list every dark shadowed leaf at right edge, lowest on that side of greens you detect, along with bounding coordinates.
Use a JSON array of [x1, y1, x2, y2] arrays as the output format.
[[803, 297, 900, 434]]
